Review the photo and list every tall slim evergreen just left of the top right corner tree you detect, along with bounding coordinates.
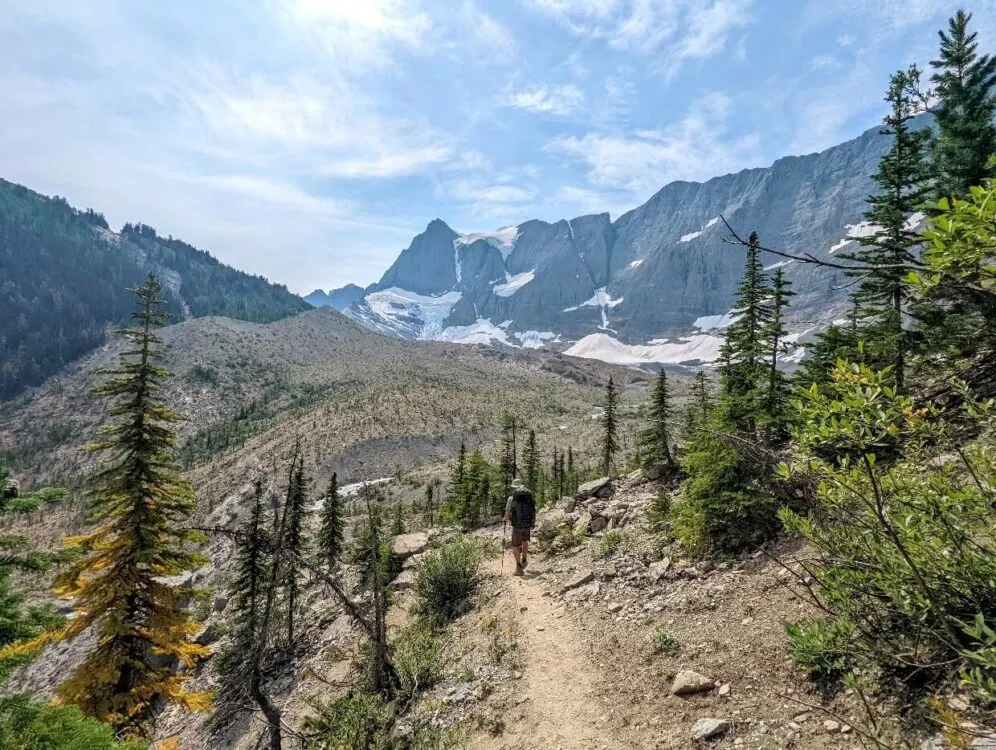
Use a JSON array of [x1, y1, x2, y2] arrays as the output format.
[[842, 67, 930, 391]]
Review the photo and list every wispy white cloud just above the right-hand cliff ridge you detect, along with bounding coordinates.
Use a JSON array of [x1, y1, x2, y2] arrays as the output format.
[[547, 93, 758, 198]]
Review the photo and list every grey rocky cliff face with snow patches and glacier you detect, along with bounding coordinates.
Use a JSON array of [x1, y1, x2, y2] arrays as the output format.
[[347, 122, 889, 363]]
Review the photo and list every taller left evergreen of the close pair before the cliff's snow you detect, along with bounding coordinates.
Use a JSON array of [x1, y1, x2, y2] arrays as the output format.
[[720, 232, 772, 432]]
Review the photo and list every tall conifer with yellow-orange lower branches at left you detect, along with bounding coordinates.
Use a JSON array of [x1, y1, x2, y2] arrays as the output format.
[[58, 274, 210, 733]]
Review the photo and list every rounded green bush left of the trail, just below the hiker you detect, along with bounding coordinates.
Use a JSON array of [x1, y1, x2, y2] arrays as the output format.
[[414, 537, 482, 625]]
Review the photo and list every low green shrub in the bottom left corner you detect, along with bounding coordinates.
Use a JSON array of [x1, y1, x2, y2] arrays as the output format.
[[0, 695, 148, 750]]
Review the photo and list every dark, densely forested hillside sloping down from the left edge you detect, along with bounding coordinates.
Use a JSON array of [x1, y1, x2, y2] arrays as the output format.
[[0, 180, 310, 400]]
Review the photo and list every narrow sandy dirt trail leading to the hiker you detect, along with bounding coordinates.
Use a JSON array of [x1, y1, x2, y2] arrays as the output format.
[[468, 555, 646, 750]]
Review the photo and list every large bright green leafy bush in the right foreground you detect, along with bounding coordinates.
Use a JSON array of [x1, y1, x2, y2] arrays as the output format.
[[780, 363, 996, 699]]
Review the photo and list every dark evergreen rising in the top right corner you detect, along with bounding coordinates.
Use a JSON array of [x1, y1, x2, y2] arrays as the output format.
[[930, 10, 996, 203]]
